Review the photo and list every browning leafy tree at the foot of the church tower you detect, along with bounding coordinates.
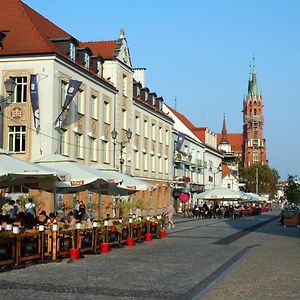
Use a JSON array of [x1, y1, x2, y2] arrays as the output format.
[[240, 164, 279, 198]]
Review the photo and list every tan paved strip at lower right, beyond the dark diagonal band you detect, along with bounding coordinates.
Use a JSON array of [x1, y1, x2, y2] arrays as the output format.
[[203, 212, 300, 300]]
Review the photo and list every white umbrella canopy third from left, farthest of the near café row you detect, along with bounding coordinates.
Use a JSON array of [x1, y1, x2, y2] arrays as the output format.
[[91, 164, 155, 196]]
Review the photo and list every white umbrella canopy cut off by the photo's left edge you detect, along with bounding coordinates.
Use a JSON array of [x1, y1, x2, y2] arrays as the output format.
[[0, 149, 58, 188]]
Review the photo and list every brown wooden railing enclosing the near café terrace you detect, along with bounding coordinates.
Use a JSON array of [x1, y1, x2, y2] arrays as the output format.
[[0, 216, 166, 269]]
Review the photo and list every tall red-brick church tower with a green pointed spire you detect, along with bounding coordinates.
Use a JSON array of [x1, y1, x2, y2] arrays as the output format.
[[242, 58, 268, 168]]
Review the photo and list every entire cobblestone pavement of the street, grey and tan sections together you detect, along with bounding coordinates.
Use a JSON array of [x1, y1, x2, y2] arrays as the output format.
[[0, 214, 300, 300]]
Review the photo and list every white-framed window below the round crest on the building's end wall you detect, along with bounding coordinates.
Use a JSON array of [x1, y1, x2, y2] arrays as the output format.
[[8, 126, 26, 152]]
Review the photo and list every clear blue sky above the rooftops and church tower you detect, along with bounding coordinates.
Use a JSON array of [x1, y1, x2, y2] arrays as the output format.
[[23, 0, 300, 179]]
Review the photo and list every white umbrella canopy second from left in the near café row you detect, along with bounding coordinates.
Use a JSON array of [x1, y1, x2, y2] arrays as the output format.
[[35, 154, 116, 193]]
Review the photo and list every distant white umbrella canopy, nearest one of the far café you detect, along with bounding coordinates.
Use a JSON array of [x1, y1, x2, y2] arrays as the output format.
[[196, 187, 246, 200]]
